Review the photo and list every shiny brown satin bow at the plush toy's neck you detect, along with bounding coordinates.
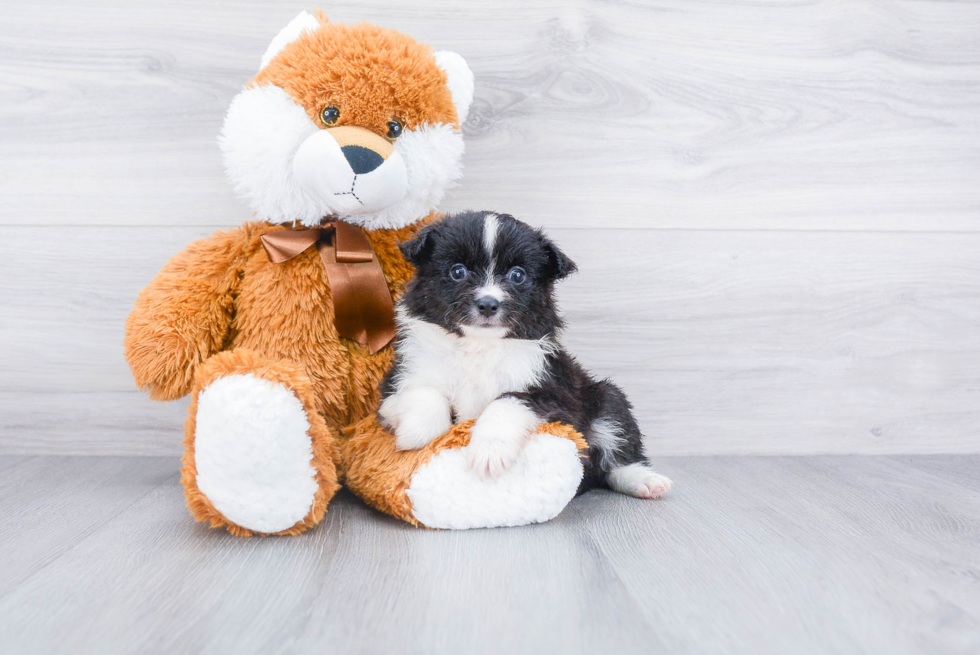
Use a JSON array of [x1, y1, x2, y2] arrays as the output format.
[[261, 219, 395, 355]]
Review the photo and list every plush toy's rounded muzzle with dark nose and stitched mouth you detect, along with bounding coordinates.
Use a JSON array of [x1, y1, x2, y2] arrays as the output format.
[[293, 125, 408, 214]]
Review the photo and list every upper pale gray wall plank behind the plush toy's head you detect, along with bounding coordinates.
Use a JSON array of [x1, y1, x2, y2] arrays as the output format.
[[0, 0, 980, 231]]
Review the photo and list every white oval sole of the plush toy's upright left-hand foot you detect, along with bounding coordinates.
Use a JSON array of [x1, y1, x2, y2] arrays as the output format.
[[194, 374, 318, 533]]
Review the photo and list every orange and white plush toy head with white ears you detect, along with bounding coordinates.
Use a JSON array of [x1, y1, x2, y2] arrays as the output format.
[[219, 12, 473, 229]]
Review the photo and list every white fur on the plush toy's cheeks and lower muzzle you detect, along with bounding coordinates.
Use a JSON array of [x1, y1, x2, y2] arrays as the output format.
[[218, 85, 463, 229]]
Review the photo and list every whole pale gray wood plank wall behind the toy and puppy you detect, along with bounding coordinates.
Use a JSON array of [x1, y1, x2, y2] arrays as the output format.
[[0, 0, 980, 455]]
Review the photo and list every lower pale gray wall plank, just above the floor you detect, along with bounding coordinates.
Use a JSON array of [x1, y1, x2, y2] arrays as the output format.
[[0, 227, 980, 454]]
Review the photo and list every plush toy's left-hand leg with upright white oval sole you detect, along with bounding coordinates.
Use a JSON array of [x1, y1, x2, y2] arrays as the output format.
[[181, 349, 339, 537]]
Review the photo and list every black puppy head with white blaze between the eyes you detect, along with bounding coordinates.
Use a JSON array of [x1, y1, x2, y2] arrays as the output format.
[[399, 212, 576, 339]]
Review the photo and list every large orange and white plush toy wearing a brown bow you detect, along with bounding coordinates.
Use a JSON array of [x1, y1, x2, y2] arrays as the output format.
[[125, 12, 582, 536]]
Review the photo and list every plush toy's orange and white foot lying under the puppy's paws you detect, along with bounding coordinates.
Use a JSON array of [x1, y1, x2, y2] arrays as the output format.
[[343, 417, 587, 529]]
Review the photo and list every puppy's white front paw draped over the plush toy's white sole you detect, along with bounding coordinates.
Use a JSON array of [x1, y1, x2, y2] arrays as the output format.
[[466, 398, 538, 480]]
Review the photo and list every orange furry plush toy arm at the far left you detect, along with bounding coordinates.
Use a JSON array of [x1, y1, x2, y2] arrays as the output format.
[[125, 228, 249, 400]]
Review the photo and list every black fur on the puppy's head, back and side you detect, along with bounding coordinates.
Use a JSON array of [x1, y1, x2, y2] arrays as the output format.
[[381, 212, 648, 493]]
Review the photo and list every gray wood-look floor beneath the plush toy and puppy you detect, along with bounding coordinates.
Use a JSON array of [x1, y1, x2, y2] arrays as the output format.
[[0, 455, 980, 655]]
